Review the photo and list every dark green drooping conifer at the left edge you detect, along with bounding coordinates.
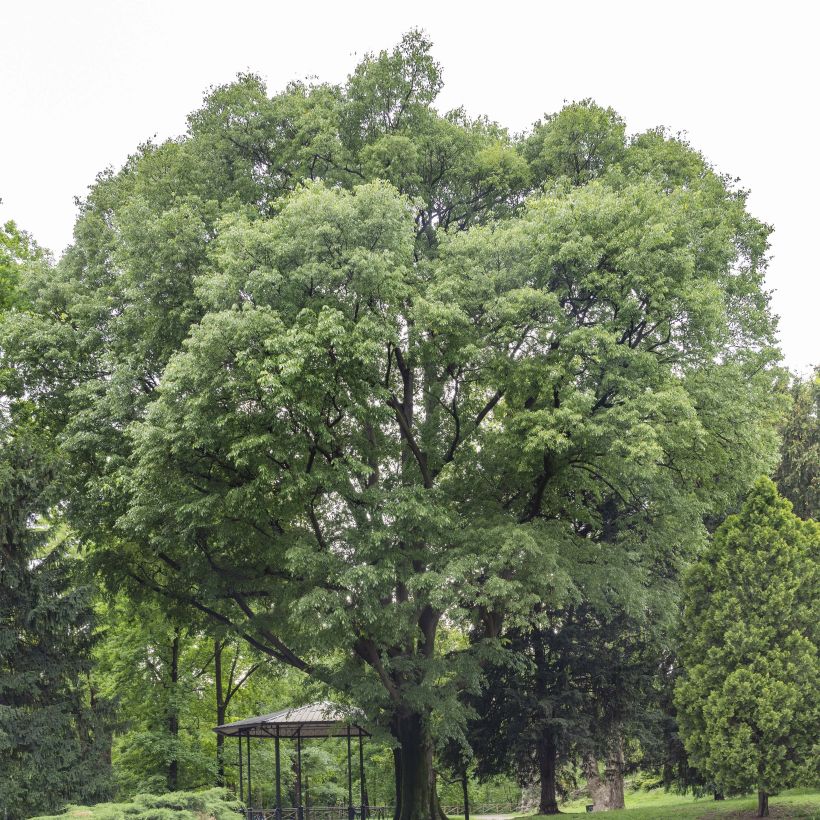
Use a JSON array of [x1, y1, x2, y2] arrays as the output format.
[[0, 421, 112, 818]]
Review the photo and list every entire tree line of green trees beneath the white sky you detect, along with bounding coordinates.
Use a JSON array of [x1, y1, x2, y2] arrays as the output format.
[[0, 31, 818, 820]]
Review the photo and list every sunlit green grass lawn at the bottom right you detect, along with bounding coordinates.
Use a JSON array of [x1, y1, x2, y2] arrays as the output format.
[[544, 789, 820, 820]]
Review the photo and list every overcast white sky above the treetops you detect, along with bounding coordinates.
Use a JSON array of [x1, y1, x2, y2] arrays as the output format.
[[0, 0, 820, 372]]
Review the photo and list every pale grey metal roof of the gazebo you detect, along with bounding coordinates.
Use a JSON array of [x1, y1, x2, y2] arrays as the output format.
[[214, 701, 368, 738]]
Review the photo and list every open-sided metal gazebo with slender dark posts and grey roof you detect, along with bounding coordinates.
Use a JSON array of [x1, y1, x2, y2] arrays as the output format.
[[214, 701, 370, 820]]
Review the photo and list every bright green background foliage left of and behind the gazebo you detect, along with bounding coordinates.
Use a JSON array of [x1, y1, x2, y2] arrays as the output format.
[[93, 594, 314, 796]]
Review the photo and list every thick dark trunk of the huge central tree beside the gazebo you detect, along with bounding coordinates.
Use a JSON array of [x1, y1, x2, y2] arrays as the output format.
[[393, 711, 443, 820]]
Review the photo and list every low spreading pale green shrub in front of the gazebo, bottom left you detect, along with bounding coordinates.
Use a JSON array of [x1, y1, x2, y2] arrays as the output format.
[[35, 789, 241, 820]]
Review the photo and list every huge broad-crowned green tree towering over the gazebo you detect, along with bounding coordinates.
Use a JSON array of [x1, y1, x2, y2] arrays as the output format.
[[2, 32, 777, 820]]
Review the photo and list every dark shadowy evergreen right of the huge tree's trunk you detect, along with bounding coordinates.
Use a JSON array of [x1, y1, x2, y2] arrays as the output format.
[[469, 602, 662, 814]]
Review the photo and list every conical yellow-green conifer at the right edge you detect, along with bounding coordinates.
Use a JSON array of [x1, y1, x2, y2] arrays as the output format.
[[675, 478, 820, 793]]
